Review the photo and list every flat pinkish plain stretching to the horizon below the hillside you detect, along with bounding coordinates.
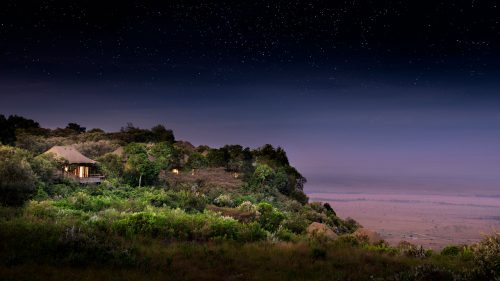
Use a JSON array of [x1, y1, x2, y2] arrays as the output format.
[[308, 192, 500, 247]]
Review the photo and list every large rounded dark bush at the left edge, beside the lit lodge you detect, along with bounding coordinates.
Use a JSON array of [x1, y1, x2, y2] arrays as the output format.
[[0, 145, 36, 206]]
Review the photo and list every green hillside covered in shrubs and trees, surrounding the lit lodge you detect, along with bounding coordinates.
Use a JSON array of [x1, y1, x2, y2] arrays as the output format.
[[0, 115, 500, 280]]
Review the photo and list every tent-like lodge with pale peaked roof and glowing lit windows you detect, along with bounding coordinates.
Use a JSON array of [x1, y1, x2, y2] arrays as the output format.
[[44, 146, 102, 184]]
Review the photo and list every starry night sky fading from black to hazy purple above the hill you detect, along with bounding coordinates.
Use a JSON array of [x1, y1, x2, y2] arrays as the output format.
[[0, 0, 500, 193]]
